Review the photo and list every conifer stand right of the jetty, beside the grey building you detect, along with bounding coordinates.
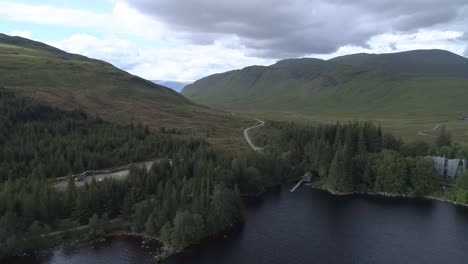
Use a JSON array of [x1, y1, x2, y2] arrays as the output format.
[[262, 122, 468, 200]]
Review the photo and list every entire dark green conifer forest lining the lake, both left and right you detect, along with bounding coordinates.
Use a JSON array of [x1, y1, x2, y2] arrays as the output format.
[[0, 89, 468, 256]]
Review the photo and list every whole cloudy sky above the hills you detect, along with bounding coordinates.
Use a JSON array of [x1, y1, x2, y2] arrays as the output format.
[[0, 0, 468, 81]]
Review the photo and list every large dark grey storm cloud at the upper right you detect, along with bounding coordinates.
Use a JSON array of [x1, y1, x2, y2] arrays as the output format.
[[127, 0, 468, 58]]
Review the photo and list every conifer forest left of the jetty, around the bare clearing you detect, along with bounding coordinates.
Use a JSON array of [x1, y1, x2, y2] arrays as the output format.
[[0, 89, 294, 256]]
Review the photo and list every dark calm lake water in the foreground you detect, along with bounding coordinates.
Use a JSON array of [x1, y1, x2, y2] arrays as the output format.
[[9, 185, 468, 264]]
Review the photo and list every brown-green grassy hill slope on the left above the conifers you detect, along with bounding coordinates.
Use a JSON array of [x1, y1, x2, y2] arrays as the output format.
[[0, 34, 252, 153]]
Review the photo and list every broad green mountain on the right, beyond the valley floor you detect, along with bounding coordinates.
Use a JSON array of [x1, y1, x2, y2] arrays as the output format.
[[182, 50, 468, 119]]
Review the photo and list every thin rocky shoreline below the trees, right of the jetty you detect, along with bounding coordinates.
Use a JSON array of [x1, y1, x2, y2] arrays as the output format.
[[310, 184, 468, 207]]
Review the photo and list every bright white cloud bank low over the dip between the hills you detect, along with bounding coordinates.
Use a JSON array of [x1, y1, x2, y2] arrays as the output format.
[[48, 34, 273, 81]]
